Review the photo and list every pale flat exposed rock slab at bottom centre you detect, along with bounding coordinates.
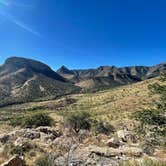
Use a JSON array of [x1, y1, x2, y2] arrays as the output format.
[[55, 145, 143, 166]]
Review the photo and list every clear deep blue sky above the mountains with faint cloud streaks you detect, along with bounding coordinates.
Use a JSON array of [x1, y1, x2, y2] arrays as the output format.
[[0, 0, 166, 69]]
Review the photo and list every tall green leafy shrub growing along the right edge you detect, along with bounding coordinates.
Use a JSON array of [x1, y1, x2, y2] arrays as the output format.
[[131, 73, 166, 146]]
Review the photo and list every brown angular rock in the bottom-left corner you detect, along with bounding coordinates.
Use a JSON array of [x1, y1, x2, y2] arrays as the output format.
[[1, 156, 26, 166]]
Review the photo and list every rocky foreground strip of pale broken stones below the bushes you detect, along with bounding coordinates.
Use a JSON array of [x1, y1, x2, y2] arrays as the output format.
[[0, 127, 166, 166]]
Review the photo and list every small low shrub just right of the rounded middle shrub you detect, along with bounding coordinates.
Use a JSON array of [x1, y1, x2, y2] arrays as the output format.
[[93, 121, 115, 135]]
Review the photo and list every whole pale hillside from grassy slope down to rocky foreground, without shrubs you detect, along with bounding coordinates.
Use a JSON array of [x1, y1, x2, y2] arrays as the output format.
[[0, 78, 166, 166]]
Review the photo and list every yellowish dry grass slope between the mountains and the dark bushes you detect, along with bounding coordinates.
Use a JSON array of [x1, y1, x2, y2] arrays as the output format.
[[0, 78, 158, 130]]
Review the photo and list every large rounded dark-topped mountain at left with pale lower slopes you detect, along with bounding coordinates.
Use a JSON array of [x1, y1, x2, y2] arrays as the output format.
[[0, 57, 79, 106]]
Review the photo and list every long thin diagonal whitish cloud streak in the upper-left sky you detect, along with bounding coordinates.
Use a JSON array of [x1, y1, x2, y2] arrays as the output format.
[[0, 11, 42, 38]]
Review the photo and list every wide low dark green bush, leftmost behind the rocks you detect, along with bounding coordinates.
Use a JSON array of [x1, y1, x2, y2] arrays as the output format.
[[10, 113, 53, 128]]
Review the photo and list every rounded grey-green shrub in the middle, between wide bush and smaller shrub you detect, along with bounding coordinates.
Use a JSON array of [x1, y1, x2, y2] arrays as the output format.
[[65, 111, 91, 133]]
